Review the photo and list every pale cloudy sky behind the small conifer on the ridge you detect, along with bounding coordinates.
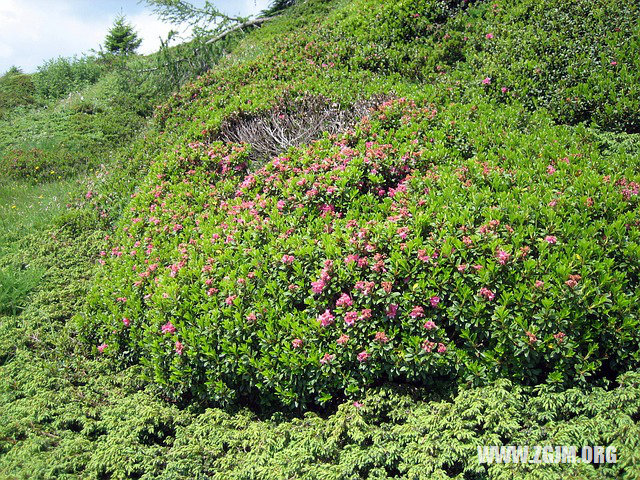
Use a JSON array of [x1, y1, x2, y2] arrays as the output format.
[[0, 0, 271, 75]]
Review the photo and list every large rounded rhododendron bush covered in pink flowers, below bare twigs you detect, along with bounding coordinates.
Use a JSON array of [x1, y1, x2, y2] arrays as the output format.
[[81, 98, 640, 406]]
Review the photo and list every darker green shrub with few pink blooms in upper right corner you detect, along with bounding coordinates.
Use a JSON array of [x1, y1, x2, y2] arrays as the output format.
[[454, 0, 640, 133]]
